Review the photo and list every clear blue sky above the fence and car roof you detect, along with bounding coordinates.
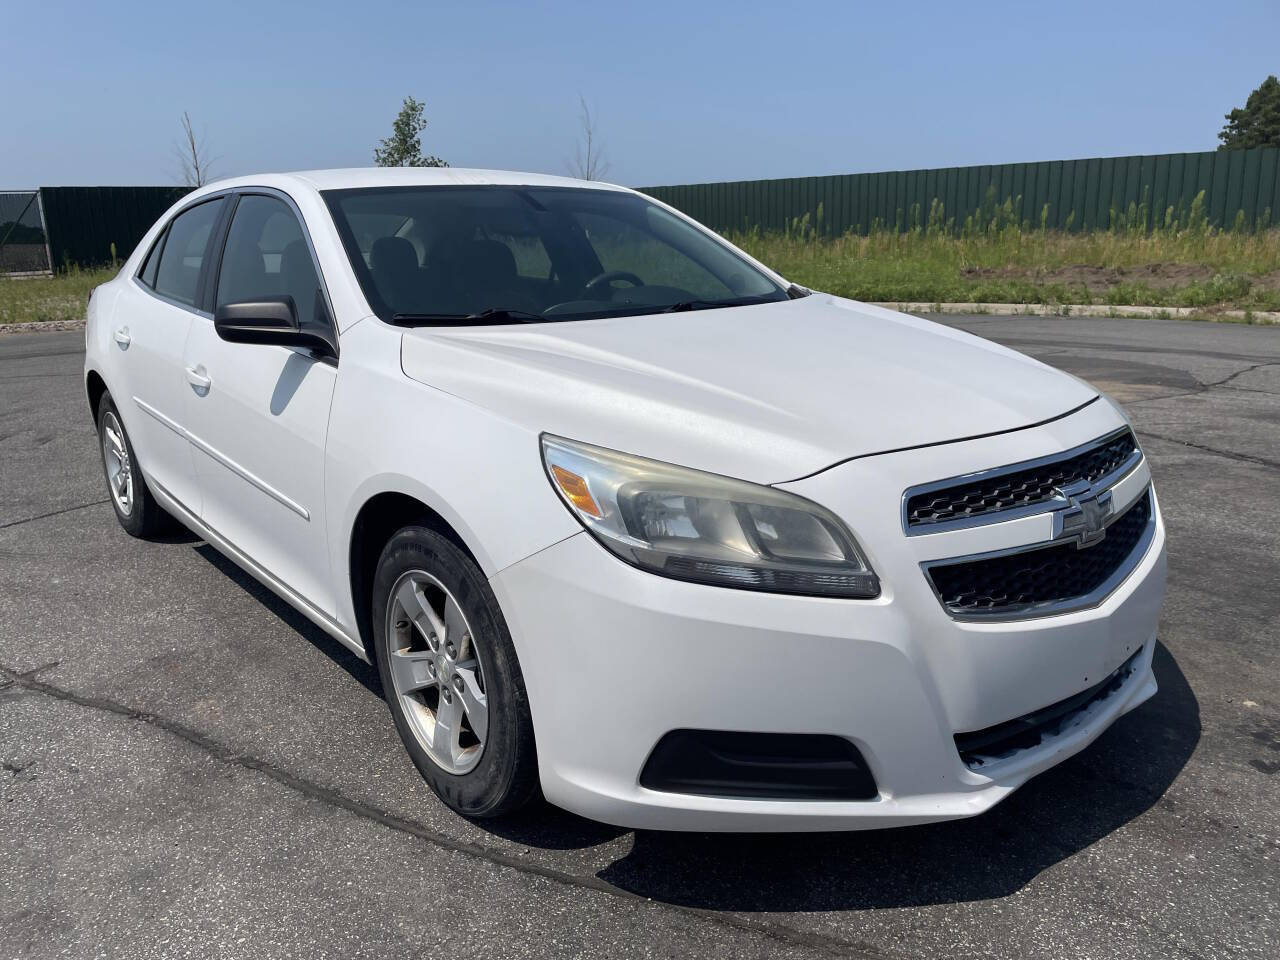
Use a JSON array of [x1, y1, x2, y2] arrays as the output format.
[[0, 0, 1280, 188]]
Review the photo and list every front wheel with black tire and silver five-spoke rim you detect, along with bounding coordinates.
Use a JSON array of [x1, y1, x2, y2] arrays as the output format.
[[372, 526, 538, 817]]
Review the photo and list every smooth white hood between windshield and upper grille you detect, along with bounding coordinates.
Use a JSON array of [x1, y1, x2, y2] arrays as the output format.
[[402, 293, 1096, 484]]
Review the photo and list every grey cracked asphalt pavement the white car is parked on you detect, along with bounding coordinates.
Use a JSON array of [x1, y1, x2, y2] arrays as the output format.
[[0, 317, 1280, 960]]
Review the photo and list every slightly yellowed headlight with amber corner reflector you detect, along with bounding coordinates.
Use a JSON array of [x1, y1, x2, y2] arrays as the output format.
[[543, 435, 879, 599]]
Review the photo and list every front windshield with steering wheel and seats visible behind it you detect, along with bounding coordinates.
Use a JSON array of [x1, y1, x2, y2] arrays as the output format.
[[324, 186, 787, 325]]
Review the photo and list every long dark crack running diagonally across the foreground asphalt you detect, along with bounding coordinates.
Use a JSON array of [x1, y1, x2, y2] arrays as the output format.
[[0, 663, 888, 960]]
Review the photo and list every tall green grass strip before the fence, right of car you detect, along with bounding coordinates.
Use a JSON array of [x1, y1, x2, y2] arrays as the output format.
[[730, 195, 1280, 316]]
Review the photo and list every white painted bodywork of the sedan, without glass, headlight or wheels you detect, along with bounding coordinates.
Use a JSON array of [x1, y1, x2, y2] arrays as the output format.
[[86, 169, 1165, 829]]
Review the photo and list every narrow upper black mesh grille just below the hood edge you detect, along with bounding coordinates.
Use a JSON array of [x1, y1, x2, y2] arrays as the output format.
[[905, 429, 1138, 529]]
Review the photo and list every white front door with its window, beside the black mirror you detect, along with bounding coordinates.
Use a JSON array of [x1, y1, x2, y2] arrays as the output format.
[[183, 191, 338, 613]]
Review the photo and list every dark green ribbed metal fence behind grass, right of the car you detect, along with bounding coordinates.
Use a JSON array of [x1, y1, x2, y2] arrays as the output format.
[[641, 147, 1280, 234]]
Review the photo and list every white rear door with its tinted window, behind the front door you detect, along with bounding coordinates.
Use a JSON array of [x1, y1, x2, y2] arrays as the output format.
[[111, 197, 225, 516]]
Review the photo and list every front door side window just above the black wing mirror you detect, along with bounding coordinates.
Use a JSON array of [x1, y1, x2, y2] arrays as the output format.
[[218, 196, 328, 335]]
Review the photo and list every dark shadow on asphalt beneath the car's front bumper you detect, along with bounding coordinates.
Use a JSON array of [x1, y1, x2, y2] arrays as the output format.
[[598, 644, 1201, 911]]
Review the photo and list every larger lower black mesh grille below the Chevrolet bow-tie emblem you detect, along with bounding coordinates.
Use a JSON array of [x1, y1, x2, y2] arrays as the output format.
[[928, 489, 1151, 617]]
